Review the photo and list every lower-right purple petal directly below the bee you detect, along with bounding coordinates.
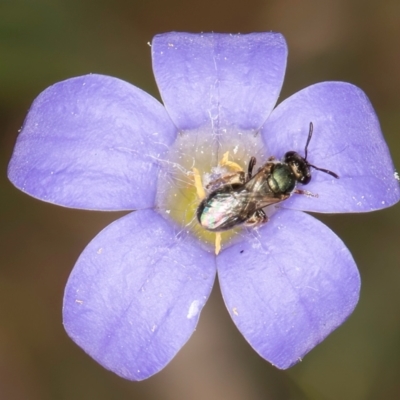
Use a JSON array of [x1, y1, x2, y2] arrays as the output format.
[[217, 210, 360, 368]]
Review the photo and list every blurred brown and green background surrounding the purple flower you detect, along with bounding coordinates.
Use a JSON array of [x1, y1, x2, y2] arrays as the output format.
[[0, 0, 400, 400]]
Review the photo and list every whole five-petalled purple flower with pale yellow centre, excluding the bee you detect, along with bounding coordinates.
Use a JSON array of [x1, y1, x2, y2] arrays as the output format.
[[9, 33, 400, 380]]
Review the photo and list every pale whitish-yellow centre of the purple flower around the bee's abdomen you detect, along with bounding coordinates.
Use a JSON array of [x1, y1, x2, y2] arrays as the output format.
[[156, 129, 267, 252]]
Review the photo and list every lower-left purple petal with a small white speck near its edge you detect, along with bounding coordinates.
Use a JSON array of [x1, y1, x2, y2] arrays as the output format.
[[64, 210, 215, 380]]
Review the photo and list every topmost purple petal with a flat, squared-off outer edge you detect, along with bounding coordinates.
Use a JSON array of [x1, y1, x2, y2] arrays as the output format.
[[152, 32, 287, 132]]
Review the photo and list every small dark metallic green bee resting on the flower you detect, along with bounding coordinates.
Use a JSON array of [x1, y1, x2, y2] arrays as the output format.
[[196, 122, 339, 232]]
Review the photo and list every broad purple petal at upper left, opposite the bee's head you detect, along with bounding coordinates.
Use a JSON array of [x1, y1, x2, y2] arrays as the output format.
[[8, 75, 176, 210]]
